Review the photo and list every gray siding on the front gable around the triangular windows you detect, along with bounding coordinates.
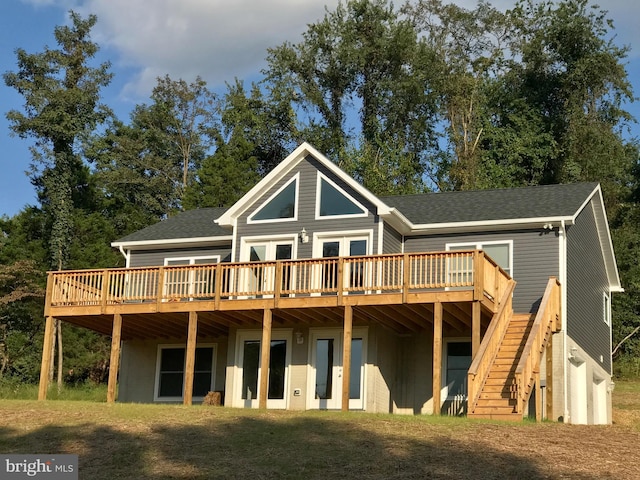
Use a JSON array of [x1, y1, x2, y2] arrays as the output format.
[[236, 157, 378, 261]]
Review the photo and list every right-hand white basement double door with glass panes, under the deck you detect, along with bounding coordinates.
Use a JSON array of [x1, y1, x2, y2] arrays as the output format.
[[307, 328, 367, 410]]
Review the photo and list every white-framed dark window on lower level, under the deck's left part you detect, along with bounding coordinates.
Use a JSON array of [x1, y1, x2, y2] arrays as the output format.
[[154, 343, 216, 402]]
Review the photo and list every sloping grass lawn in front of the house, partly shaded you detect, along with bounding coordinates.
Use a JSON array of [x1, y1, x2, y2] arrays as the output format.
[[0, 382, 640, 480]]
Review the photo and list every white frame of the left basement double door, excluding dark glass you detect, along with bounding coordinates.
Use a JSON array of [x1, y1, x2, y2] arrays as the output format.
[[231, 328, 293, 409]]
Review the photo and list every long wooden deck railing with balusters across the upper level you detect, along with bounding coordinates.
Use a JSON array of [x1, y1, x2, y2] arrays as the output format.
[[49, 250, 509, 307]]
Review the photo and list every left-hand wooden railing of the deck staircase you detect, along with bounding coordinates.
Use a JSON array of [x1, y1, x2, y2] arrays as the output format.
[[467, 280, 516, 412]]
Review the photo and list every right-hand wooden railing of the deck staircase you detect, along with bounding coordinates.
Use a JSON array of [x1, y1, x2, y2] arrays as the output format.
[[515, 277, 560, 413]]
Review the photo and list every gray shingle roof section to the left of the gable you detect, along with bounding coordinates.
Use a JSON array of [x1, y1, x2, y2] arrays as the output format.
[[115, 208, 231, 243]]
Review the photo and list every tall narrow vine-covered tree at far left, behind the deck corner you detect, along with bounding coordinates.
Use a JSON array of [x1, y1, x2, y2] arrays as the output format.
[[4, 11, 111, 386]]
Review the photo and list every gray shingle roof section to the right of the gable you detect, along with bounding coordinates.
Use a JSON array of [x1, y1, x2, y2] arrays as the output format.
[[381, 183, 598, 225]]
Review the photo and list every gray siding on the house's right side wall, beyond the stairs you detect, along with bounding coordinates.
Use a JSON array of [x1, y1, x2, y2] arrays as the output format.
[[567, 203, 611, 371]]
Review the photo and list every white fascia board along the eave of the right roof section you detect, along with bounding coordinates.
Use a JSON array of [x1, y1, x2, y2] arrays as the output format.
[[408, 217, 573, 235]]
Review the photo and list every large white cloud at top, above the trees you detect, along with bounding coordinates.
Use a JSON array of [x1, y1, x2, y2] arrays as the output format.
[[63, 0, 338, 96]]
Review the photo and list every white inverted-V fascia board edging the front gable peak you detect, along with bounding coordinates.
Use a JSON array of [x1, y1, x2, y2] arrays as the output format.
[[215, 142, 389, 227]]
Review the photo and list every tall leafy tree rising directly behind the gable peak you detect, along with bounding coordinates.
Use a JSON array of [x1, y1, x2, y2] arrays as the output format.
[[265, 0, 436, 188]]
